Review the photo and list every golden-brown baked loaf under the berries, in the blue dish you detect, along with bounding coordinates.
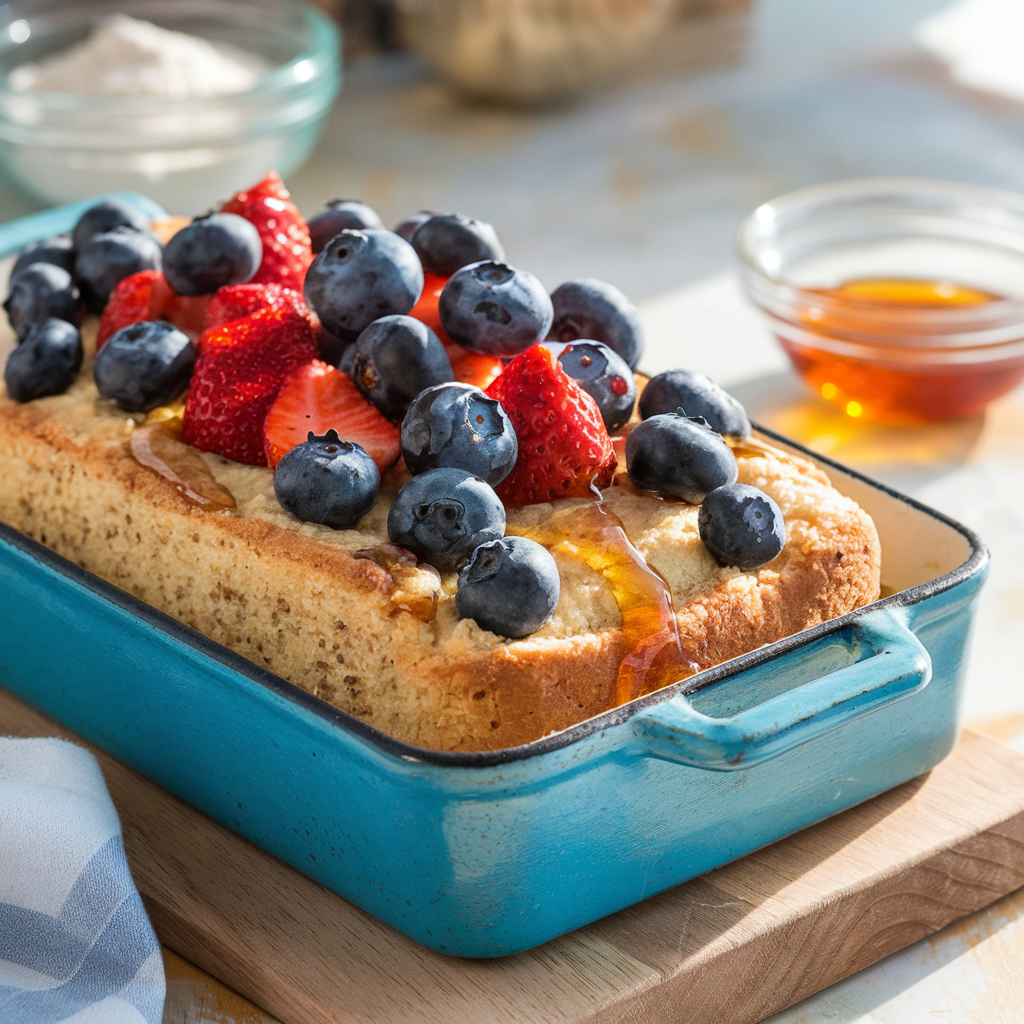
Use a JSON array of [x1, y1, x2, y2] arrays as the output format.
[[0, 325, 881, 751]]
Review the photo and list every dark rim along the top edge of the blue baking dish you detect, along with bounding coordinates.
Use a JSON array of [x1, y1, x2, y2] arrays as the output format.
[[0, 417, 988, 768]]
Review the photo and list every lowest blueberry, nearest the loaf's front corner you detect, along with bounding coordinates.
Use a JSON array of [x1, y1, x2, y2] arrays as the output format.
[[455, 537, 559, 639]]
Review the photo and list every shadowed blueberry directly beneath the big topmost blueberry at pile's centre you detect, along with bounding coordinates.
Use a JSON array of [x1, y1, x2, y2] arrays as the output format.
[[348, 316, 455, 420]]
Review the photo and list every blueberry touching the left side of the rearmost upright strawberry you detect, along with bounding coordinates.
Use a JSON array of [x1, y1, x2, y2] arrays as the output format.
[[163, 213, 263, 295]]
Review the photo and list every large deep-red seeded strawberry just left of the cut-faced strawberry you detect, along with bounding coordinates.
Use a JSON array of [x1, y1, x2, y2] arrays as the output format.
[[182, 309, 316, 466]]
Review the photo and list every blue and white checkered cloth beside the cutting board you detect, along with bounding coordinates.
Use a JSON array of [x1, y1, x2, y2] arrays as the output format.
[[0, 738, 164, 1024]]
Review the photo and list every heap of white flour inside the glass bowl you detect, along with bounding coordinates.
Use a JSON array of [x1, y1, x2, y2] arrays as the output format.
[[7, 14, 268, 99]]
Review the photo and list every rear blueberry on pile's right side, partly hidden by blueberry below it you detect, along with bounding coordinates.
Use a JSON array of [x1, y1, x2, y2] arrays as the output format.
[[548, 278, 643, 370]]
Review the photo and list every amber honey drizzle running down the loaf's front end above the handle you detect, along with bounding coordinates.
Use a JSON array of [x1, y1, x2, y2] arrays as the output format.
[[507, 502, 700, 705]]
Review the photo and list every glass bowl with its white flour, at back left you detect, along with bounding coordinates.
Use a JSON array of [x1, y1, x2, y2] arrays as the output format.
[[0, 0, 341, 212]]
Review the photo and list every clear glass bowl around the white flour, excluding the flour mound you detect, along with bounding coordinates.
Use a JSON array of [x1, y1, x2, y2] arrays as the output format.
[[0, 0, 341, 213]]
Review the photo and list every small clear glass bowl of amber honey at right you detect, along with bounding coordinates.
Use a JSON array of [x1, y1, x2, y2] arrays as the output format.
[[737, 178, 1024, 423]]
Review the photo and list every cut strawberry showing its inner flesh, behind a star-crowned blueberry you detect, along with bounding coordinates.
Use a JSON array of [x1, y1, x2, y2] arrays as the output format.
[[263, 359, 400, 473]]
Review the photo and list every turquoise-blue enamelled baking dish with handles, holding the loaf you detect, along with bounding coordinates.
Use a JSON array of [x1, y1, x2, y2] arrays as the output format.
[[0, 195, 987, 956]]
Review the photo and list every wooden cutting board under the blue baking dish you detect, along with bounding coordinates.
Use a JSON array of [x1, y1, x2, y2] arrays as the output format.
[[0, 690, 1024, 1024]]
